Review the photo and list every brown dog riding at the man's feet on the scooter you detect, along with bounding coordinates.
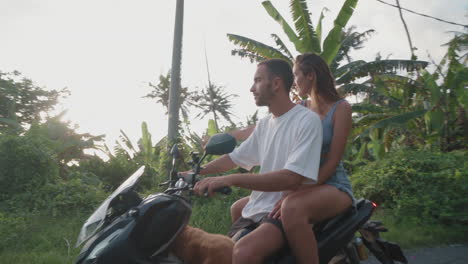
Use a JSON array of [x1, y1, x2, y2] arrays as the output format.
[[171, 226, 234, 264]]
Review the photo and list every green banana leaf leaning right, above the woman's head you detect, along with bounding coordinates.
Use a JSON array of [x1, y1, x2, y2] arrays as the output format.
[[321, 0, 358, 65]]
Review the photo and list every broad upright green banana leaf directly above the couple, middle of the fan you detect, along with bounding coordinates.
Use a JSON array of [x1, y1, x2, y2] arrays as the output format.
[[290, 0, 322, 54]]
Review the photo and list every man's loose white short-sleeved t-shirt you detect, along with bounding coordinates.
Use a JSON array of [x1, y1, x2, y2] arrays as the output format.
[[229, 105, 322, 222]]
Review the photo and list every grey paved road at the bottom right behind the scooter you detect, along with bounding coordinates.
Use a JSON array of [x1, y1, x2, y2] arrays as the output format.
[[363, 245, 468, 264]]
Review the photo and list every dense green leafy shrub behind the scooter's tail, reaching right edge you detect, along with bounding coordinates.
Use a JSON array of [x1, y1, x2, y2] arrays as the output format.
[[351, 150, 468, 224]]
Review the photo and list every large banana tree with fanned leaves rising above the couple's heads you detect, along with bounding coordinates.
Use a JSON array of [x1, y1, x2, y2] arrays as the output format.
[[228, 0, 427, 98]]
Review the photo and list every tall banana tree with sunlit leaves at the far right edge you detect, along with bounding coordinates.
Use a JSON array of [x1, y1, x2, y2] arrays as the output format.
[[419, 33, 468, 151]]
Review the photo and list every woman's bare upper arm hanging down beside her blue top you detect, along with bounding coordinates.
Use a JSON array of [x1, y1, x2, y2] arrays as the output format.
[[317, 101, 352, 184]]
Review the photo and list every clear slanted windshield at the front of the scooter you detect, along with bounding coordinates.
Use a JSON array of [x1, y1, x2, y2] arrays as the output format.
[[76, 166, 145, 247]]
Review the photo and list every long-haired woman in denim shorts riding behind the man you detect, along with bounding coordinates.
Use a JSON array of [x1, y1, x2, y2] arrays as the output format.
[[231, 53, 354, 264]]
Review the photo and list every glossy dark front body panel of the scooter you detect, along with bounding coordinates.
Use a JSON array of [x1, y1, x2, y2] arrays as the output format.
[[76, 193, 191, 264]]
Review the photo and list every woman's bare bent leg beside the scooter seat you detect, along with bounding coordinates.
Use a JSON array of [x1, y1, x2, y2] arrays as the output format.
[[281, 184, 352, 264]]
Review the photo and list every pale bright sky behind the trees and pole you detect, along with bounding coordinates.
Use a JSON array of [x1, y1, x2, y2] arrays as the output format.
[[0, 0, 468, 151]]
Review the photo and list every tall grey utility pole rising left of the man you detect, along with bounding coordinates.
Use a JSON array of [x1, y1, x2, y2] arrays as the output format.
[[167, 0, 184, 144]]
